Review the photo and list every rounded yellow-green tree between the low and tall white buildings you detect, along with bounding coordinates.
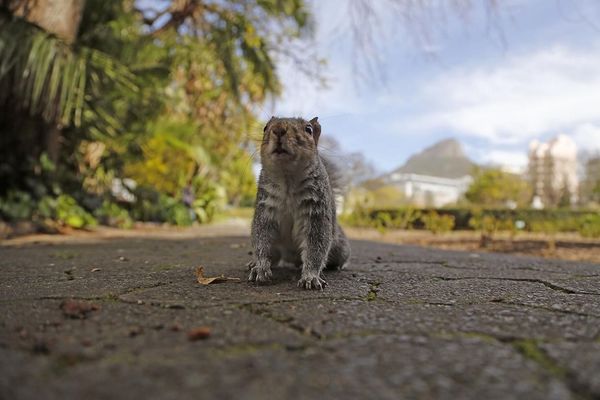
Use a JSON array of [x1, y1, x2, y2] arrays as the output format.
[[465, 169, 532, 207]]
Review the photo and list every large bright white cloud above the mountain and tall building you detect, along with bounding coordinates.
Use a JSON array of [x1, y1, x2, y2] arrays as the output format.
[[404, 46, 600, 143]]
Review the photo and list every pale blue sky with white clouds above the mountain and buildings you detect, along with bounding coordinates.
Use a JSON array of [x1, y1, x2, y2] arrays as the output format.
[[260, 0, 600, 172]]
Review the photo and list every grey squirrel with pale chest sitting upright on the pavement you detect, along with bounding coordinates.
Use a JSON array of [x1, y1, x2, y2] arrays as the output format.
[[248, 117, 350, 290]]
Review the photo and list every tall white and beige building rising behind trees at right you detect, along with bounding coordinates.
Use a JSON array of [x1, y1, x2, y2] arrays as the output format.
[[528, 135, 579, 206]]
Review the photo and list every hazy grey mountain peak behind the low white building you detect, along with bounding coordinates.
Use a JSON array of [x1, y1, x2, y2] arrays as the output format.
[[393, 139, 477, 178]]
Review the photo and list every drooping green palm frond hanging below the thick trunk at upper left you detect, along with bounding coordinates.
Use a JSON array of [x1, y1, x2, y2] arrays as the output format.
[[0, 14, 138, 126]]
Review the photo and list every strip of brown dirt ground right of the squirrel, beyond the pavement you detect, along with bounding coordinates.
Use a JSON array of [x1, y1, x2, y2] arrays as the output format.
[[345, 227, 600, 263]]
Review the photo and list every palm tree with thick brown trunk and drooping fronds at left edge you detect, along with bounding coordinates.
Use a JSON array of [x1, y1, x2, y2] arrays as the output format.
[[0, 0, 135, 190]]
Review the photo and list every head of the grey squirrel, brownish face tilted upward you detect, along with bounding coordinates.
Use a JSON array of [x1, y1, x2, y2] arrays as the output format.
[[260, 117, 321, 167]]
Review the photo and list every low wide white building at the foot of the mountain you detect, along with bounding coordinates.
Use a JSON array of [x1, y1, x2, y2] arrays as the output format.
[[387, 172, 473, 207]]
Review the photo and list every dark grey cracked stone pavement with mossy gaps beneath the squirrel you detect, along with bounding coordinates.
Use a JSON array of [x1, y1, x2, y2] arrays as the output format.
[[0, 227, 600, 400]]
